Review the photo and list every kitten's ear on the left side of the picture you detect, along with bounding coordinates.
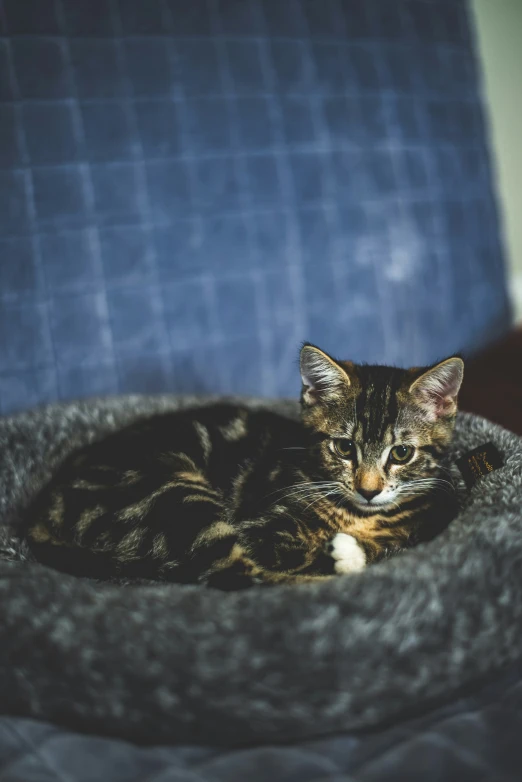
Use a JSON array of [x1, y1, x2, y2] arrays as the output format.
[[300, 344, 350, 407]]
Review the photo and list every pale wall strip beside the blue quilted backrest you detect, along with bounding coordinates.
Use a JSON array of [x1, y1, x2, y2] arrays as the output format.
[[471, 0, 522, 320]]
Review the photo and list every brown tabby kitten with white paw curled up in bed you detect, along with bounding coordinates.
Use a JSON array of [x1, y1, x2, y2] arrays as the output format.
[[26, 345, 463, 589]]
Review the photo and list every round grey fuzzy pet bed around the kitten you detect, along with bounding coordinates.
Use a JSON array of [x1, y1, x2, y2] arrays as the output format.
[[0, 397, 522, 745]]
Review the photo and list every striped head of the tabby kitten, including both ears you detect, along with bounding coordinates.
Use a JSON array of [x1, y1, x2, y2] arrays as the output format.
[[301, 345, 463, 513]]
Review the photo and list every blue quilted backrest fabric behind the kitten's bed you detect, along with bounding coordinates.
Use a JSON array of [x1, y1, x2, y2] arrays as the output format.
[[0, 0, 509, 413]]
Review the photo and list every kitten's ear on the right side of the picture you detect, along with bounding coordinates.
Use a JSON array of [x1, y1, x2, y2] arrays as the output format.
[[409, 356, 464, 421]]
